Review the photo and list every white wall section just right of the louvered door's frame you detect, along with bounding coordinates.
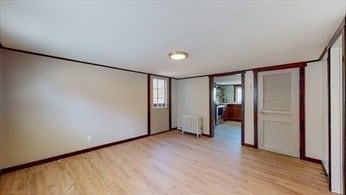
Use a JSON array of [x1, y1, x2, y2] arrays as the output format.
[[305, 60, 329, 163]]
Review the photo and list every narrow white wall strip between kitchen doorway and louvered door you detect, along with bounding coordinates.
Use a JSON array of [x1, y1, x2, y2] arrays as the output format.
[[244, 71, 254, 145]]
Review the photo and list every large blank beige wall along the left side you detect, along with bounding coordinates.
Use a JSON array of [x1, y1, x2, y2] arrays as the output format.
[[1, 50, 148, 167]]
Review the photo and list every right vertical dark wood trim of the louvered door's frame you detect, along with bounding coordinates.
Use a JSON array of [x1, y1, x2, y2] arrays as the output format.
[[299, 67, 308, 159]]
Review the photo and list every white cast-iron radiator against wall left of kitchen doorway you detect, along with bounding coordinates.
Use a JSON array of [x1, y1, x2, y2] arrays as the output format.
[[181, 114, 202, 138]]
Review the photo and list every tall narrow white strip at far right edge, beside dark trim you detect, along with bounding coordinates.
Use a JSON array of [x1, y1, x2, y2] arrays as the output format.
[[330, 34, 345, 194]]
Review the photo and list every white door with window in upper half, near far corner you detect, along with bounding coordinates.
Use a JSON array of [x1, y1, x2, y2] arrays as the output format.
[[150, 76, 170, 134]]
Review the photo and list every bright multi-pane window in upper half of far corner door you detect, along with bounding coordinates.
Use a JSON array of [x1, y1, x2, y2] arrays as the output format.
[[153, 79, 167, 108]]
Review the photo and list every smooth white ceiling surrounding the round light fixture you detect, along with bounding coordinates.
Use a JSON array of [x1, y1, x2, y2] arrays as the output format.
[[0, 0, 346, 78]]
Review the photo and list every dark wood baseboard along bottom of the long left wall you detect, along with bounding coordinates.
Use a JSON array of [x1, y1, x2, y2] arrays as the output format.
[[1, 135, 148, 174]]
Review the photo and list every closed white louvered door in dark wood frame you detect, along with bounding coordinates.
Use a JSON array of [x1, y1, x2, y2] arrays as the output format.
[[257, 68, 299, 157]]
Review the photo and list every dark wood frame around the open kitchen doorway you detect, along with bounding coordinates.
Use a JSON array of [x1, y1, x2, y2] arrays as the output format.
[[208, 71, 245, 145]]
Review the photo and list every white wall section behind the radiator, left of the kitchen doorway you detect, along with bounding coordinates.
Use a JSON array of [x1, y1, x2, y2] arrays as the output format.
[[177, 77, 209, 135]]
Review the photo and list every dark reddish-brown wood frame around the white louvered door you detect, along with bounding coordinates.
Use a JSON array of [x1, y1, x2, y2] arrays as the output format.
[[253, 62, 306, 158]]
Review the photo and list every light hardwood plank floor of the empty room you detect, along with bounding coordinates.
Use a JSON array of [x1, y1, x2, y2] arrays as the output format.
[[0, 128, 329, 195]]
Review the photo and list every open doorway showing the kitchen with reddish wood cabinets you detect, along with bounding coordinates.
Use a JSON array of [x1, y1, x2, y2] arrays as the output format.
[[210, 73, 245, 145]]
